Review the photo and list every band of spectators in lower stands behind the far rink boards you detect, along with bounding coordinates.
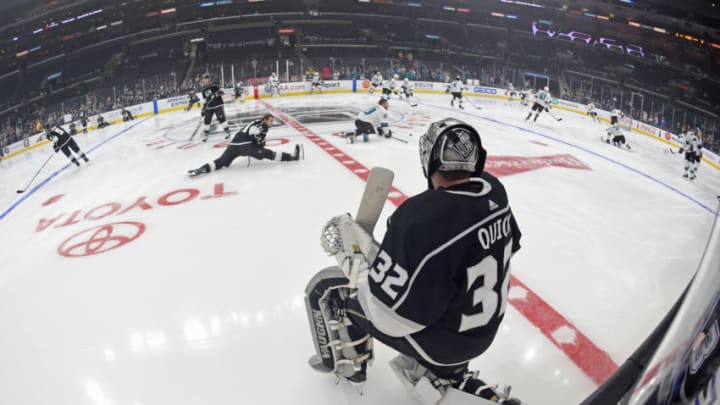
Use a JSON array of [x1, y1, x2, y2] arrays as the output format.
[[0, 54, 720, 158]]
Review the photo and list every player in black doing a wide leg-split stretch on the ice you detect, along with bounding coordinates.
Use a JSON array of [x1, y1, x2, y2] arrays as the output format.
[[188, 114, 302, 177]]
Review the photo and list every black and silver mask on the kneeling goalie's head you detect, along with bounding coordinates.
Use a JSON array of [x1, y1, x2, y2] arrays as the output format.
[[420, 118, 487, 189]]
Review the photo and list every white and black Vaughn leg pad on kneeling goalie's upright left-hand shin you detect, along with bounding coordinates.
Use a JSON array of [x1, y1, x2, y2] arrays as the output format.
[[305, 267, 373, 378]]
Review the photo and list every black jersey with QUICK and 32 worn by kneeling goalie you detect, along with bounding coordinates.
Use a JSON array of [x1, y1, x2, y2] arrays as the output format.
[[358, 173, 521, 365]]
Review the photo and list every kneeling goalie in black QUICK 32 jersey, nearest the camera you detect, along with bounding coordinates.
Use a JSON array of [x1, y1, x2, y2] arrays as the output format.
[[305, 118, 521, 404]]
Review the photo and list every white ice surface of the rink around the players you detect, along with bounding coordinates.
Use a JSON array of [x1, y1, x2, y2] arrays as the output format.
[[0, 94, 720, 405]]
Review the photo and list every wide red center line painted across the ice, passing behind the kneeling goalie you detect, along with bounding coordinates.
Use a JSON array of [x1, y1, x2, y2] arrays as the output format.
[[260, 101, 618, 385]]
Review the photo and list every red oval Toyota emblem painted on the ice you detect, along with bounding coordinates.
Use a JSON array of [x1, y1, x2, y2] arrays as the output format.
[[58, 221, 145, 257]]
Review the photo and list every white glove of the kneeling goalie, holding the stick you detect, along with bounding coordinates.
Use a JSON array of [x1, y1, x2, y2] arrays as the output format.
[[320, 214, 378, 288]]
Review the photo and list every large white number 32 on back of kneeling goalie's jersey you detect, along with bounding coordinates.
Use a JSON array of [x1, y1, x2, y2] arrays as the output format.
[[459, 240, 512, 332]]
